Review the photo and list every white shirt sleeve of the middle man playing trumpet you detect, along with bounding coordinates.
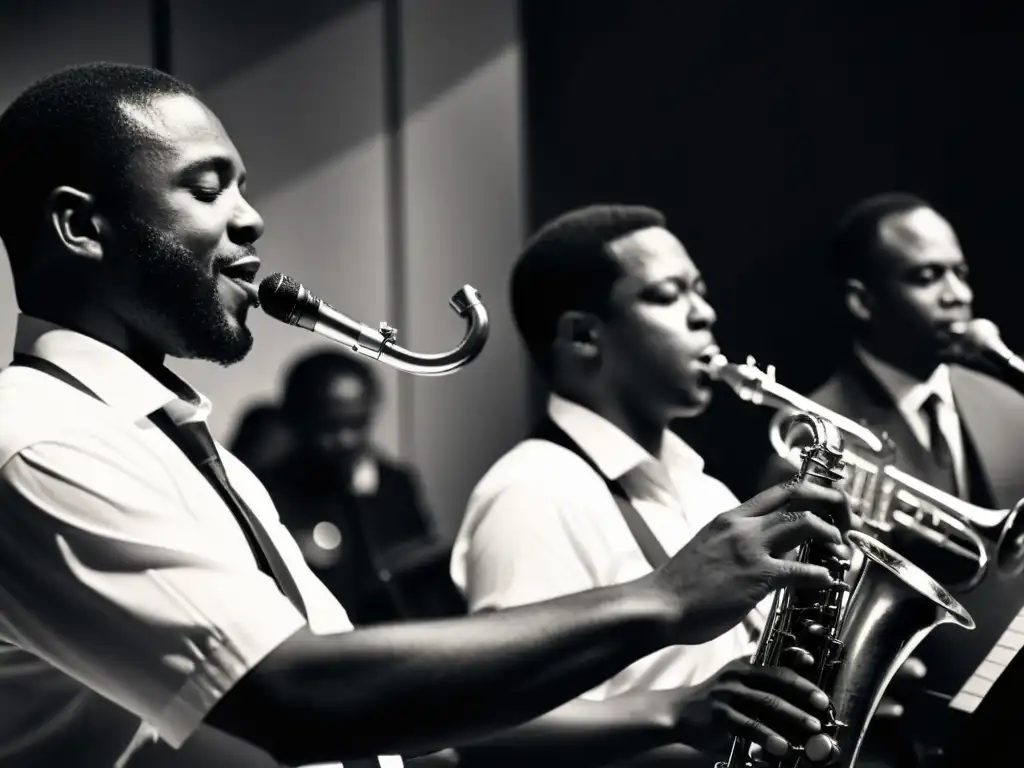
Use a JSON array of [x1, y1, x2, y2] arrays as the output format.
[[464, 475, 598, 611]]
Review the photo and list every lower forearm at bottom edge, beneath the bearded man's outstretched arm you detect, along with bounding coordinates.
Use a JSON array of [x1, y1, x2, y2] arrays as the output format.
[[458, 691, 688, 768]]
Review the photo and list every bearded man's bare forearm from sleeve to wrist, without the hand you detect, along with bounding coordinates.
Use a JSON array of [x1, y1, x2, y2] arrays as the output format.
[[251, 584, 681, 762]]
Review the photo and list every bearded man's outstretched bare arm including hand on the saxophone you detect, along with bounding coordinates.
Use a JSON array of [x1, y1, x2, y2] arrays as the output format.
[[207, 483, 848, 764]]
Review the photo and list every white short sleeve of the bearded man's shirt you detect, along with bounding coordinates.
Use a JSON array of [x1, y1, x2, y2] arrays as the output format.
[[0, 434, 305, 748]]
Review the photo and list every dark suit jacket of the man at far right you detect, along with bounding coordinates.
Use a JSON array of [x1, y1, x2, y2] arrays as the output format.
[[762, 359, 1024, 761]]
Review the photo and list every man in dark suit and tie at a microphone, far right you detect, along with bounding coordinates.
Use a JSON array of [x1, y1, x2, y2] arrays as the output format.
[[762, 194, 1024, 765]]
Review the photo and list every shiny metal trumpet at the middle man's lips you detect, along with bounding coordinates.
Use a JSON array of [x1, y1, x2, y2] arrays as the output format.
[[703, 349, 1024, 593]]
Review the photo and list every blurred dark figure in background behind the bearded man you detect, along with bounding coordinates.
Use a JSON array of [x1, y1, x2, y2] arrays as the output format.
[[258, 351, 464, 625]]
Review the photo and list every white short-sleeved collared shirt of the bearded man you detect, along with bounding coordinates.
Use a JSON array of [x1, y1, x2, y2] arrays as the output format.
[[0, 315, 400, 768]]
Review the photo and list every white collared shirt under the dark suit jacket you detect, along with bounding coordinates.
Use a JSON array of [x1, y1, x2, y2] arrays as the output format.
[[854, 345, 968, 488]]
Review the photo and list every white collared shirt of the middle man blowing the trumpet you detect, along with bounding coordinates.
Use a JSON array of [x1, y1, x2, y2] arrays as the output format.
[[452, 395, 765, 699]]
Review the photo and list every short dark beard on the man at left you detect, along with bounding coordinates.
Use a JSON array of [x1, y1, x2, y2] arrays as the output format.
[[118, 211, 253, 366]]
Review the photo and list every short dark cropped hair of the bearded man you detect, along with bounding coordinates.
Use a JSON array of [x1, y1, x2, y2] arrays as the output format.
[[0, 61, 197, 266]]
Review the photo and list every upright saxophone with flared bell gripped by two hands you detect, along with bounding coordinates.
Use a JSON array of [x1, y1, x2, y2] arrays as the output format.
[[708, 355, 975, 768]]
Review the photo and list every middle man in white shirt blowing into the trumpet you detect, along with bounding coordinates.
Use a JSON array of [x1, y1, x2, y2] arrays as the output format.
[[452, 206, 913, 766]]
